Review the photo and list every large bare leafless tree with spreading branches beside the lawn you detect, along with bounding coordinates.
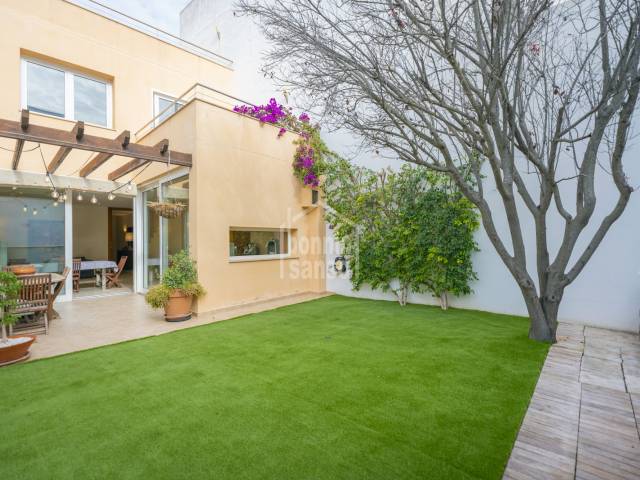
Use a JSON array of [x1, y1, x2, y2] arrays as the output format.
[[240, 0, 640, 341]]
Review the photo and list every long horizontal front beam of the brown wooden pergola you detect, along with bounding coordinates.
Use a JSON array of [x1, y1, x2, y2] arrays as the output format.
[[0, 119, 192, 167]]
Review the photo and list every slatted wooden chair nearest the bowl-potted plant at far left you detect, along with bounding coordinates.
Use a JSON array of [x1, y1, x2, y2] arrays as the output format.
[[11, 273, 53, 334]]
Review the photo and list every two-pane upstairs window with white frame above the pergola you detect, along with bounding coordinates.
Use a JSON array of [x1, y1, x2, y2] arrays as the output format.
[[22, 58, 112, 128]]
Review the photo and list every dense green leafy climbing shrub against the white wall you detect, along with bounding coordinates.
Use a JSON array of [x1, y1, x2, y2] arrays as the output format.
[[324, 159, 478, 309]]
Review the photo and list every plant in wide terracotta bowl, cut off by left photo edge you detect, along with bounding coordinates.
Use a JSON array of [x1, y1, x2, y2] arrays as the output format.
[[0, 272, 36, 366]]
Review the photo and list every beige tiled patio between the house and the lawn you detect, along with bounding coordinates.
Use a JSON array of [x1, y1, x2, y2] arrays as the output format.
[[31, 293, 332, 360]]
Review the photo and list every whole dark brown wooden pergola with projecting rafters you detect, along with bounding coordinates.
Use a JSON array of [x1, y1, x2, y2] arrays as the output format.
[[0, 110, 192, 181]]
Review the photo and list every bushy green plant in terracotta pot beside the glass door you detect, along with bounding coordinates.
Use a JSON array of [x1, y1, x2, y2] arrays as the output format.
[[145, 250, 205, 322]]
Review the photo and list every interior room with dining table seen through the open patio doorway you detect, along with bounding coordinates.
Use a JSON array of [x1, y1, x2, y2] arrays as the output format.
[[72, 191, 134, 298]]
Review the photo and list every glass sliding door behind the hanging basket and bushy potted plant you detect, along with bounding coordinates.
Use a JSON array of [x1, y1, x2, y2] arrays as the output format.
[[141, 175, 189, 290]]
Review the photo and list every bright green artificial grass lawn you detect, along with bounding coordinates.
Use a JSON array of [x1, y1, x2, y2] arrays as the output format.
[[0, 296, 548, 480]]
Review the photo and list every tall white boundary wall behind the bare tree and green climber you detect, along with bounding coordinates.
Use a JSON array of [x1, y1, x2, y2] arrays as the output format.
[[180, 0, 640, 332]]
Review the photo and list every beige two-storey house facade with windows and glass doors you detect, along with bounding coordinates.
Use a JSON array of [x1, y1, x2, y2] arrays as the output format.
[[0, 0, 326, 313]]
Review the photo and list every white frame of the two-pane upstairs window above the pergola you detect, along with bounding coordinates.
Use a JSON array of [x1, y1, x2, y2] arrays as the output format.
[[20, 57, 113, 129]]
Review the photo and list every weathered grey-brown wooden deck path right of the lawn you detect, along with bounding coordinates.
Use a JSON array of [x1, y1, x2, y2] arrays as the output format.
[[503, 324, 640, 480]]
